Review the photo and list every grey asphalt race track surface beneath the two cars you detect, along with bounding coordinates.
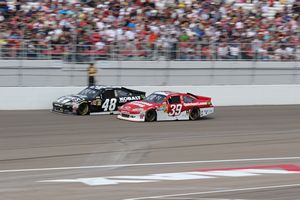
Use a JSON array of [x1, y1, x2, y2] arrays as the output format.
[[0, 105, 300, 200]]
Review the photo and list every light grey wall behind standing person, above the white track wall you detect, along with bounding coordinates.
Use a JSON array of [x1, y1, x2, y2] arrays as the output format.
[[0, 60, 300, 87]]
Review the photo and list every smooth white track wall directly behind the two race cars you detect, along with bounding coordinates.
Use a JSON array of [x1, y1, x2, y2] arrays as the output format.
[[0, 85, 300, 110]]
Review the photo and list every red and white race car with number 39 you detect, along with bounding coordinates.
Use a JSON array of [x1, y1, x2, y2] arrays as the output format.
[[118, 91, 214, 122]]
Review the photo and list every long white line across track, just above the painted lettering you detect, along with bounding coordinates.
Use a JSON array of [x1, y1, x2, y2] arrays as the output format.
[[0, 157, 300, 173]]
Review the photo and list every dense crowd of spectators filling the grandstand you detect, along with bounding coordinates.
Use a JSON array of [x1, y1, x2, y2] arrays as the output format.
[[0, 0, 300, 60]]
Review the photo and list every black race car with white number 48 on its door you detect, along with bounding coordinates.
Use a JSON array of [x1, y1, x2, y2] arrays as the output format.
[[52, 86, 146, 115]]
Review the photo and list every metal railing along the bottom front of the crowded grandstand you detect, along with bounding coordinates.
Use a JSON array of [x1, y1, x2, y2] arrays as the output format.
[[0, 40, 300, 63]]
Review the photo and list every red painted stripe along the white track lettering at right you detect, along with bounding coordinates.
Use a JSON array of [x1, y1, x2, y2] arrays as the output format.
[[194, 164, 300, 172]]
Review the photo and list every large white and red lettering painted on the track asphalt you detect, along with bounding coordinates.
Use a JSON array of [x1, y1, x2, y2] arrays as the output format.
[[40, 165, 300, 186]]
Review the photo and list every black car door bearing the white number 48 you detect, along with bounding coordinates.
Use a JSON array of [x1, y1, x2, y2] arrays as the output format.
[[101, 89, 118, 112]]
